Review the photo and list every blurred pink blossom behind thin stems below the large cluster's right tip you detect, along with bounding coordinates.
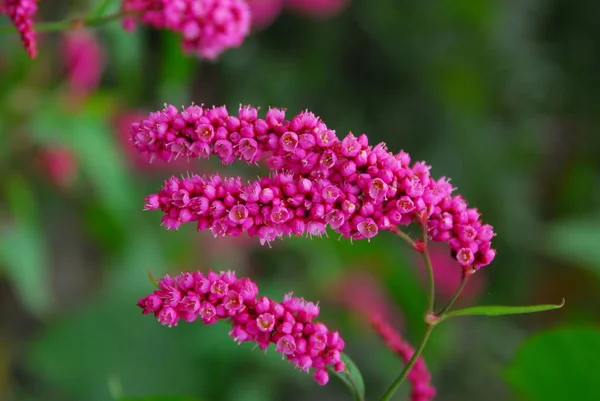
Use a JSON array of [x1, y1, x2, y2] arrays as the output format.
[[413, 243, 487, 305]]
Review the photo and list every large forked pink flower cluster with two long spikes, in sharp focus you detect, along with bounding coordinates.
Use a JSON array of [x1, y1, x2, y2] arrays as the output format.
[[130, 105, 496, 269]]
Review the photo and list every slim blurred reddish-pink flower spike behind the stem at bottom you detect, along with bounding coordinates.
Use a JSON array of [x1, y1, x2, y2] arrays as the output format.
[[369, 314, 435, 401]]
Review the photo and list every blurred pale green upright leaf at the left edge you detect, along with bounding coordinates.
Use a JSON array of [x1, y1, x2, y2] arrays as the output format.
[[0, 177, 50, 315]]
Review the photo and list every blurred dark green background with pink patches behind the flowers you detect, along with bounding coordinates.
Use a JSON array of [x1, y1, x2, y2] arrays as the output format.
[[0, 0, 600, 401]]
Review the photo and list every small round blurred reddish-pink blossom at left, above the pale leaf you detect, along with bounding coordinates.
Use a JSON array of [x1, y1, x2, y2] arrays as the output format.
[[39, 146, 79, 189]]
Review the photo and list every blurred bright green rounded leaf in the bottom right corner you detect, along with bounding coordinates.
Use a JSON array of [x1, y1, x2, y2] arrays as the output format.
[[504, 328, 600, 401]]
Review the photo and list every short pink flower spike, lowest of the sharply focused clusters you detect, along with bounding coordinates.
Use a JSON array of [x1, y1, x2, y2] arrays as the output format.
[[137, 271, 346, 385]]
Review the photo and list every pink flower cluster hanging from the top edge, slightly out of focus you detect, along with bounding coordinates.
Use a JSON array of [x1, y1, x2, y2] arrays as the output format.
[[122, 0, 250, 59]]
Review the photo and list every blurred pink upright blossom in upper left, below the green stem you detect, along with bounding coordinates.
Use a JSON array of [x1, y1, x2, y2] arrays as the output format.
[[62, 29, 104, 98]]
